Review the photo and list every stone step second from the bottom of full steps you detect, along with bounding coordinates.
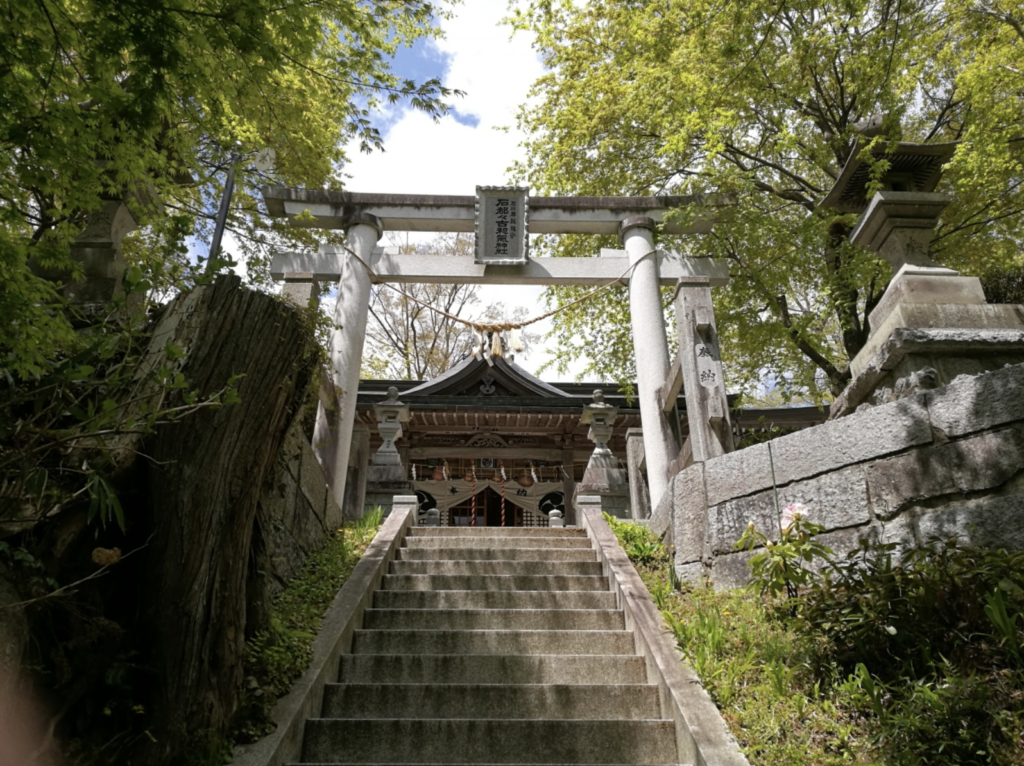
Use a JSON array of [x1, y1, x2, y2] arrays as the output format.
[[322, 683, 660, 720]]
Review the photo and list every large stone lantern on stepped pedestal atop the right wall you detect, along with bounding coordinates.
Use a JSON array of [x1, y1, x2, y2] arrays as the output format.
[[819, 142, 1024, 417]]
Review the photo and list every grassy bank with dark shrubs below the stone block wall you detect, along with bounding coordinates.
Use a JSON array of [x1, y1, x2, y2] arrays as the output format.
[[611, 520, 1024, 766]]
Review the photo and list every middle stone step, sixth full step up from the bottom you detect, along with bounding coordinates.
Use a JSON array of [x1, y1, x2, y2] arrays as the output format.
[[374, 591, 617, 609]]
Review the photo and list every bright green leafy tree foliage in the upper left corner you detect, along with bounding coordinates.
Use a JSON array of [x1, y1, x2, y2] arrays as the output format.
[[0, 0, 450, 377]]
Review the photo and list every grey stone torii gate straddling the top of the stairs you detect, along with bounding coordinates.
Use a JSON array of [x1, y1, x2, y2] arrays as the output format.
[[263, 186, 731, 518]]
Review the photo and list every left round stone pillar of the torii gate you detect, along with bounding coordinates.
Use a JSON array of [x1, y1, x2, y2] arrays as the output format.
[[313, 213, 384, 514]]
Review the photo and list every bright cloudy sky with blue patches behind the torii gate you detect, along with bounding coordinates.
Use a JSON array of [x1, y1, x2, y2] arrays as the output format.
[[335, 0, 582, 380]]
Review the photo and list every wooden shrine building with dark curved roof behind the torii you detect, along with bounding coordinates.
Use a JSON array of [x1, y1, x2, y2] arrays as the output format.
[[347, 356, 827, 526]]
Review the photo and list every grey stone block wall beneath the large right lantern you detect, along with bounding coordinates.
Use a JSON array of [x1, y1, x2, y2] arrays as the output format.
[[667, 365, 1024, 587]]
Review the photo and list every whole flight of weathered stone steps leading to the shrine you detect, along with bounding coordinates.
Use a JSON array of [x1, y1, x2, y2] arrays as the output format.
[[302, 527, 678, 764]]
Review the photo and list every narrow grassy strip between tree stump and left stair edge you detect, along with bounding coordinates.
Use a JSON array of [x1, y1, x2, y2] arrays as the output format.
[[233, 509, 382, 743]]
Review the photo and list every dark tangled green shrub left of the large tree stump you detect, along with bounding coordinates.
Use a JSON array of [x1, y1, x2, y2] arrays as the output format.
[[0, 266, 239, 531]]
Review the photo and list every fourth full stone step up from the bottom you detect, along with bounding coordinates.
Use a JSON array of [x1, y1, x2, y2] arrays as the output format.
[[352, 629, 636, 654]]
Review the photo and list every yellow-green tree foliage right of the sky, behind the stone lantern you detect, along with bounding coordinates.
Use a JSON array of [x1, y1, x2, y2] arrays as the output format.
[[512, 0, 1024, 398]]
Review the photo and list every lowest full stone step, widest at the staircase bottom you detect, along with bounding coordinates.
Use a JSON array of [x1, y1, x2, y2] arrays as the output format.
[[303, 718, 677, 764]]
